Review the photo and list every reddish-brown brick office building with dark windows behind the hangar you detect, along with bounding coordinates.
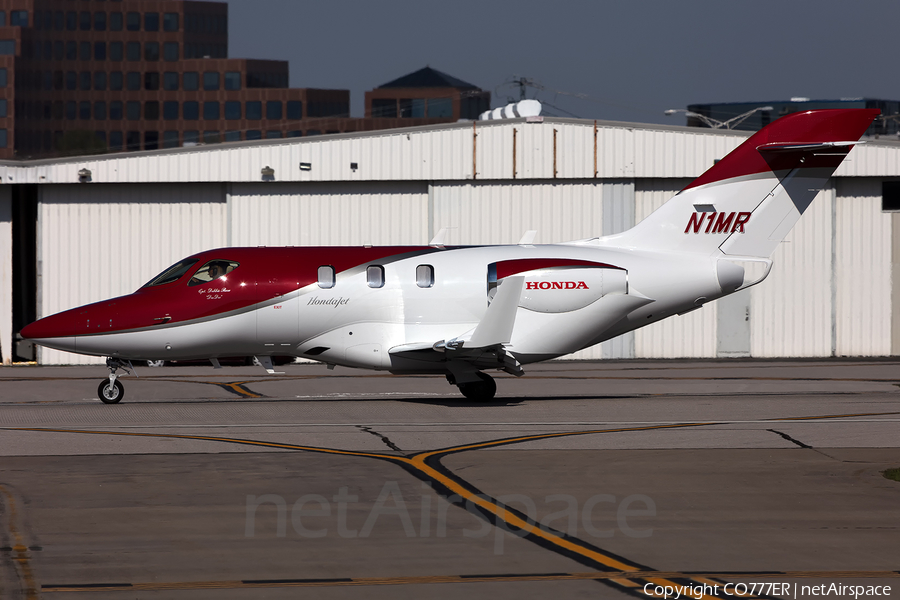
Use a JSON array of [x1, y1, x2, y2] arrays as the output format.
[[0, 0, 490, 159]]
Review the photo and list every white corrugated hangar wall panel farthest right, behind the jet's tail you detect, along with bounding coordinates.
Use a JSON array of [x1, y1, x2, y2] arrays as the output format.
[[834, 179, 892, 356]]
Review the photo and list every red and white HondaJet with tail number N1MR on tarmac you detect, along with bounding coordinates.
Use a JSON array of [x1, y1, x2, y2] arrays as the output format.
[[22, 109, 878, 403]]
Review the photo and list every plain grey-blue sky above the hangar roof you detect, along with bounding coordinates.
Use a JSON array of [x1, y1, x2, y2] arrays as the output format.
[[228, 0, 900, 124]]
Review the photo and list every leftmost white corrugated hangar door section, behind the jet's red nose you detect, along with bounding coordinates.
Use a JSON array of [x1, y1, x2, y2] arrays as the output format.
[[38, 184, 226, 364]]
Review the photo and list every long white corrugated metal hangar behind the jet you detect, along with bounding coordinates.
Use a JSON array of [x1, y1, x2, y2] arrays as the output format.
[[0, 117, 900, 364]]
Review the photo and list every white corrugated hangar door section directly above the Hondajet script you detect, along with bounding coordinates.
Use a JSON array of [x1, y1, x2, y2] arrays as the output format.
[[229, 181, 430, 246]]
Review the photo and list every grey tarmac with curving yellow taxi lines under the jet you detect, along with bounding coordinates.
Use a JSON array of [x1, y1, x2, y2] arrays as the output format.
[[0, 360, 900, 600]]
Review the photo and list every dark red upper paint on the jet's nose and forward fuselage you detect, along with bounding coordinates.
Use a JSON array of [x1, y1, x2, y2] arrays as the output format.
[[21, 246, 439, 339]]
